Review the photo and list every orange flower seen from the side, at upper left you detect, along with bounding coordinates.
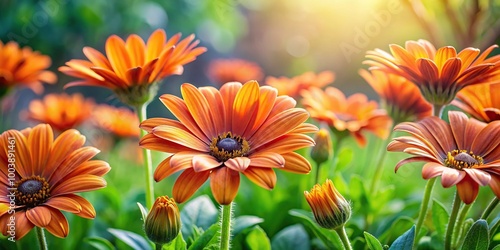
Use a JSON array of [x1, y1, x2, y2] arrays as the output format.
[[59, 29, 206, 106]]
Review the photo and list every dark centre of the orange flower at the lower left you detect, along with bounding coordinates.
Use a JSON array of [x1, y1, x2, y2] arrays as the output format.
[[14, 176, 50, 208]]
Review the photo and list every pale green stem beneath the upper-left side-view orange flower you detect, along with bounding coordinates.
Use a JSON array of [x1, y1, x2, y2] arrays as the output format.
[[136, 103, 154, 208]]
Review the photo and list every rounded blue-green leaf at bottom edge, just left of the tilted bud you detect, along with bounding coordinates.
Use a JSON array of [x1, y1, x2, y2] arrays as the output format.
[[271, 224, 311, 250]]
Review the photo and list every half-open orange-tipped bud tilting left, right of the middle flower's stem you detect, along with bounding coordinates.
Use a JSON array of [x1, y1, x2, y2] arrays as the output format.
[[304, 179, 351, 229]]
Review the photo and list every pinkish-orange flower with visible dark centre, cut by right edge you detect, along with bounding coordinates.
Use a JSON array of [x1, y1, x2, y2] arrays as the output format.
[[387, 111, 500, 204]]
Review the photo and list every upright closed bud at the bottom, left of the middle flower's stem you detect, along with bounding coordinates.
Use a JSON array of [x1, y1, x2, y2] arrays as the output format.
[[144, 196, 181, 245]]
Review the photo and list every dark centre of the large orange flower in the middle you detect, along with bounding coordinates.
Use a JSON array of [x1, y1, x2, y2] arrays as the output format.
[[210, 132, 250, 162]]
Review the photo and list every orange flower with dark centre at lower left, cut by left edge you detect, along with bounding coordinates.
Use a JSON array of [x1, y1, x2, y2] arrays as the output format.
[[0, 124, 110, 239]]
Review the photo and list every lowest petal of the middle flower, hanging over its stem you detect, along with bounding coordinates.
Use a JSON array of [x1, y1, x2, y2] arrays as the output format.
[[210, 167, 240, 205]]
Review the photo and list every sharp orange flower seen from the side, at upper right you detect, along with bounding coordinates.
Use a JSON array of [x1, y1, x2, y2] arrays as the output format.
[[364, 40, 500, 105]]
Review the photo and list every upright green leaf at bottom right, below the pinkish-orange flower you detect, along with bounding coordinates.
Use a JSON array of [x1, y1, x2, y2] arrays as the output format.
[[462, 220, 490, 250]]
